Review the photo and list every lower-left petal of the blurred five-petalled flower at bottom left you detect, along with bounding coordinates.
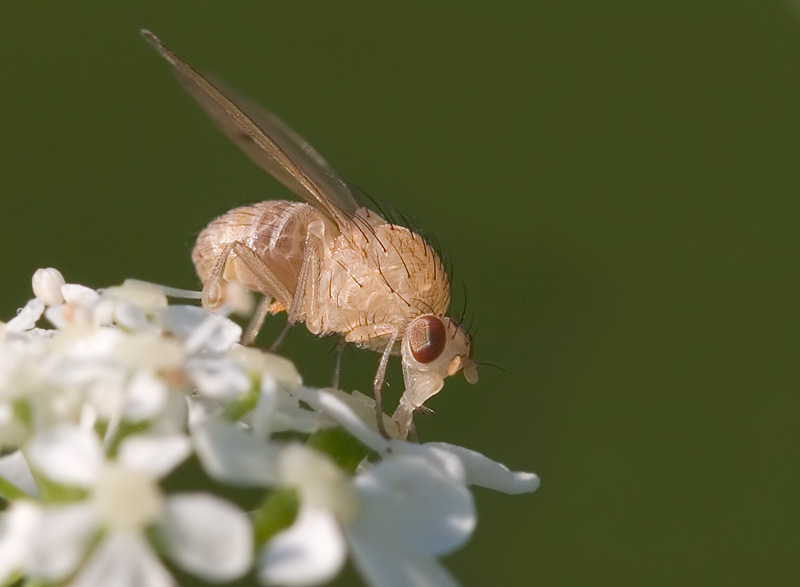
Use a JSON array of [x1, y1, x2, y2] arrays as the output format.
[[29, 503, 97, 581]]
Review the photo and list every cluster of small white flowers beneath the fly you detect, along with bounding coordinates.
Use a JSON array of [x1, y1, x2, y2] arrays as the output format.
[[0, 269, 539, 587]]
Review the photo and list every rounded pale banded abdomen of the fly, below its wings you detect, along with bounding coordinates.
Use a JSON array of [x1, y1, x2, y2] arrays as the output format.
[[192, 200, 321, 306]]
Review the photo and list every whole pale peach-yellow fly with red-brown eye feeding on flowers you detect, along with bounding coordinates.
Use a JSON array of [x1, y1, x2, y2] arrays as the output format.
[[142, 31, 478, 438]]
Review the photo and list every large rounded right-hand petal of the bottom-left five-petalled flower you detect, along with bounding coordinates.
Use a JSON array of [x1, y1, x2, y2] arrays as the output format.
[[161, 493, 253, 581]]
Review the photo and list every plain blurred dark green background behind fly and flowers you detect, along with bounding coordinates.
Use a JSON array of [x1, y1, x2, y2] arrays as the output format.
[[0, 0, 800, 585]]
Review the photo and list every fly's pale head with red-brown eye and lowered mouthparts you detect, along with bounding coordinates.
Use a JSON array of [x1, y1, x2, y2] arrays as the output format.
[[400, 314, 478, 409]]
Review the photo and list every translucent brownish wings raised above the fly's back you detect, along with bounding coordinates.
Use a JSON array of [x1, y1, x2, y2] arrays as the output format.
[[142, 30, 360, 228]]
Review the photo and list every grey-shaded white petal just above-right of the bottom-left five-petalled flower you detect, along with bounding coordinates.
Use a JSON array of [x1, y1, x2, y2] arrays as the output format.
[[193, 419, 276, 486]]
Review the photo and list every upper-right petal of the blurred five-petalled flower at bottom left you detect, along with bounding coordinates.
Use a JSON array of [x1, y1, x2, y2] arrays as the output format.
[[117, 434, 192, 478]]
